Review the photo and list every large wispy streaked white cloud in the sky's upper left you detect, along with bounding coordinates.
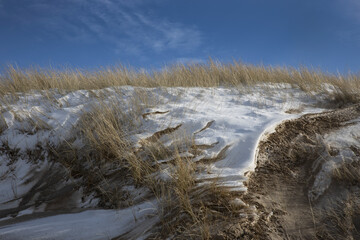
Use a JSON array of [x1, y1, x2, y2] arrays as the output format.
[[0, 0, 201, 55]]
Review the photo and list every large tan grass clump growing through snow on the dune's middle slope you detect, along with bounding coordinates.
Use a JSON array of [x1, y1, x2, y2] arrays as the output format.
[[45, 97, 242, 239]]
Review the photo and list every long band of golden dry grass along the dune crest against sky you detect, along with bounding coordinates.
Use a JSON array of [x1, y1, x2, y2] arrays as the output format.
[[0, 59, 360, 103]]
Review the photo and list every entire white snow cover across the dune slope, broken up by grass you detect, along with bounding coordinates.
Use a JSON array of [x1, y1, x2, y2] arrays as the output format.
[[0, 85, 331, 239]]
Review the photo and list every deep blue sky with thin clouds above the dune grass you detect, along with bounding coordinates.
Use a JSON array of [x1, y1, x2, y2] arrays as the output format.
[[0, 0, 360, 72]]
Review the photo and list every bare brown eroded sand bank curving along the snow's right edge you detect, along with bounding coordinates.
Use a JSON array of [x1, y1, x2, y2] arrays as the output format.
[[244, 105, 360, 239]]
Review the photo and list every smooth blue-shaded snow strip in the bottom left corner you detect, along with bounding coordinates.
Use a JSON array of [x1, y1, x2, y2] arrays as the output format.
[[0, 202, 158, 240]]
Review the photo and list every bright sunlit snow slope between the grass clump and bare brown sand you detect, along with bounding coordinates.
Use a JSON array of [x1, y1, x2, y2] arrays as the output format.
[[138, 87, 321, 190]]
